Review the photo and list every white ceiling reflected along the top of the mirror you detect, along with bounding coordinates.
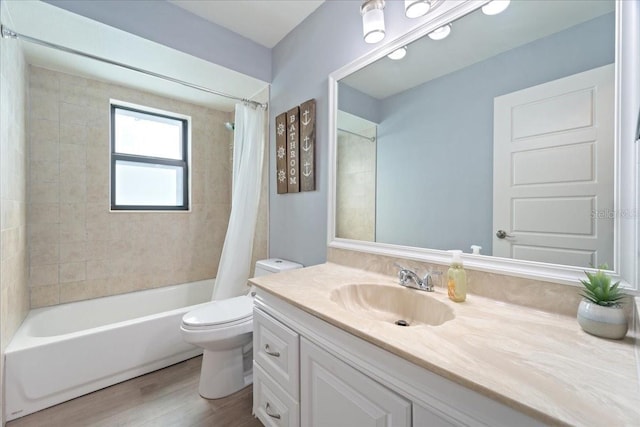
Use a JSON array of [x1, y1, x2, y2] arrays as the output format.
[[341, 0, 615, 99]]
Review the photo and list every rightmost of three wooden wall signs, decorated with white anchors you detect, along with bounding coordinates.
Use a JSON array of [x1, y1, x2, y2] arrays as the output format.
[[300, 99, 316, 191]]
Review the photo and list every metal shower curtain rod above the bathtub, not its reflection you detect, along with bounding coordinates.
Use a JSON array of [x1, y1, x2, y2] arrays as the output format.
[[0, 24, 267, 109]]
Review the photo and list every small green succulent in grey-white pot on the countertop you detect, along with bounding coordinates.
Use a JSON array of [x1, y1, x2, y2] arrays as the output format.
[[578, 265, 628, 339]]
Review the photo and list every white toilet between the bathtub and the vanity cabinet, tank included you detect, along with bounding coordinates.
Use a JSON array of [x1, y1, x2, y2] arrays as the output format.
[[180, 258, 302, 399]]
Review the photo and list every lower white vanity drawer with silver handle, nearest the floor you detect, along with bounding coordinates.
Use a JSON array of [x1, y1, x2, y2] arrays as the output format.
[[253, 361, 300, 427]]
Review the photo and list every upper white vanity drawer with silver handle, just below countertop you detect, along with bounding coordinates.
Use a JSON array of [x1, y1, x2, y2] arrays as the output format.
[[253, 309, 300, 400]]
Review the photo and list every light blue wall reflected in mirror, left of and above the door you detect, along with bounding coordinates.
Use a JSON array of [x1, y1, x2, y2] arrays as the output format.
[[376, 13, 615, 254]]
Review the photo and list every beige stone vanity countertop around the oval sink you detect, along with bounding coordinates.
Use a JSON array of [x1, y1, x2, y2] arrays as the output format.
[[251, 263, 640, 426]]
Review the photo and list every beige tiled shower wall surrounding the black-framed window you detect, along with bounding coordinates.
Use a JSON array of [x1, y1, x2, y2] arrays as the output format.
[[28, 66, 266, 308]]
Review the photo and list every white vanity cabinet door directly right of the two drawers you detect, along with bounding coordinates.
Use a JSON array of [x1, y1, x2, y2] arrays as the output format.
[[300, 338, 411, 427]]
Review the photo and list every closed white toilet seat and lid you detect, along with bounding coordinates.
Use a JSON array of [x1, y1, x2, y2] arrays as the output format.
[[182, 295, 253, 329]]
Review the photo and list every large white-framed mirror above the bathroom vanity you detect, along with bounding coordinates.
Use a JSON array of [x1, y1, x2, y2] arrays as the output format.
[[328, 0, 638, 288]]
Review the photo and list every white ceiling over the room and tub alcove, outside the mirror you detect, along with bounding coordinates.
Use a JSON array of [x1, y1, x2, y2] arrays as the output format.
[[3, 0, 322, 111]]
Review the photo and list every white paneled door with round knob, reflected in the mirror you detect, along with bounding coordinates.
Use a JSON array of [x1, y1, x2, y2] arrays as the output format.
[[493, 64, 614, 267]]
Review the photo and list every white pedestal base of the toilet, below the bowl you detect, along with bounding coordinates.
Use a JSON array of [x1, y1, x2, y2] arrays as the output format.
[[198, 347, 252, 399]]
